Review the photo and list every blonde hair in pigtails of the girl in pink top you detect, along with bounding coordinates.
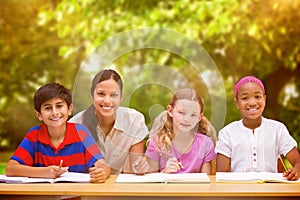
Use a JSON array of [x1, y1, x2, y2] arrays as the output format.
[[149, 88, 216, 157]]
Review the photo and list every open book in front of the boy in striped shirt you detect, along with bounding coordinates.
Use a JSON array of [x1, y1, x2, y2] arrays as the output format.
[[0, 172, 90, 183]]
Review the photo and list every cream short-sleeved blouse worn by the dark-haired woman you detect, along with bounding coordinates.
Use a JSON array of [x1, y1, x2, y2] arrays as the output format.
[[69, 107, 149, 173]]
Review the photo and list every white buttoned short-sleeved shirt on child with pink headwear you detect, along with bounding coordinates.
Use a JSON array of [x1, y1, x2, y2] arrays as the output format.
[[216, 118, 297, 172]]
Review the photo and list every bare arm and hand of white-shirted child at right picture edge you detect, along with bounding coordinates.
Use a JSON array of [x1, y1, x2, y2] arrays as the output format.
[[283, 147, 300, 180]]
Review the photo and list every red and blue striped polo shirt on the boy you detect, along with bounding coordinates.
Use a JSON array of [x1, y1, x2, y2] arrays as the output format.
[[11, 123, 103, 173]]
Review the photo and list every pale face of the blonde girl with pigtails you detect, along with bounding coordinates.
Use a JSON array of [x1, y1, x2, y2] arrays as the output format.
[[167, 99, 203, 133]]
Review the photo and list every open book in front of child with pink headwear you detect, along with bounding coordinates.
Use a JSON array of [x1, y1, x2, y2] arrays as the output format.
[[216, 172, 300, 184]]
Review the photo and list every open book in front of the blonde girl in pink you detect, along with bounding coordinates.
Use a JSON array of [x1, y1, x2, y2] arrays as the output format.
[[115, 173, 210, 183]]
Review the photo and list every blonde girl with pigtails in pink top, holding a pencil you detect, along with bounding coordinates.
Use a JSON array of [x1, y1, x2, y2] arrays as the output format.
[[136, 88, 216, 174]]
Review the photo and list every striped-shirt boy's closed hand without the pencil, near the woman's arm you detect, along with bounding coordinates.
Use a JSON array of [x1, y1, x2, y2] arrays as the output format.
[[90, 159, 111, 183]]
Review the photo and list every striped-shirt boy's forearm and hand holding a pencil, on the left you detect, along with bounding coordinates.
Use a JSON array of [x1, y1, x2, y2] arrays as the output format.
[[6, 160, 68, 178]]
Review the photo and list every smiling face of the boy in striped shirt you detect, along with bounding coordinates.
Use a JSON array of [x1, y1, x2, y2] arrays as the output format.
[[35, 98, 73, 127]]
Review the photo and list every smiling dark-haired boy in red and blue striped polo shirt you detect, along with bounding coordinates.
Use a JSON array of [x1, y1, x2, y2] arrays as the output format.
[[6, 83, 110, 182]]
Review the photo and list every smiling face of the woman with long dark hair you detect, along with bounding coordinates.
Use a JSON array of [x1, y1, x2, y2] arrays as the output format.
[[94, 79, 122, 118]]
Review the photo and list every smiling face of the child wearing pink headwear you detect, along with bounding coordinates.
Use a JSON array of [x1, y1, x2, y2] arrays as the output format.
[[234, 82, 266, 120]]
